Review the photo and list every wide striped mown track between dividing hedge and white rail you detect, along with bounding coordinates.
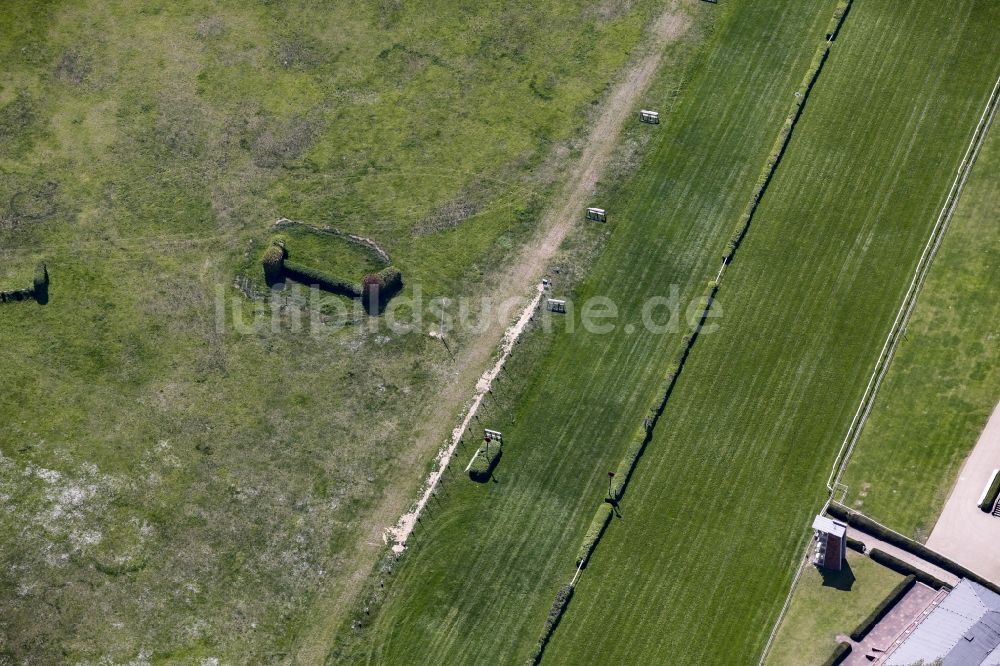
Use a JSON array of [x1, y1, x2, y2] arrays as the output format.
[[545, 0, 1000, 664]]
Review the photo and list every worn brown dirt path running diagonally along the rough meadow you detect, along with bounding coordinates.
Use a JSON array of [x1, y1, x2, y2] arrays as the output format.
[[289, 0, 695, 664]]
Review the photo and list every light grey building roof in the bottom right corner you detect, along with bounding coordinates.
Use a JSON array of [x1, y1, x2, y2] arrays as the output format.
[[885, 578, 1000, 666]]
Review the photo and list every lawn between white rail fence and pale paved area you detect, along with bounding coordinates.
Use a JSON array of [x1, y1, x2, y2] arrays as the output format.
[[842, 119, 1000, 541]]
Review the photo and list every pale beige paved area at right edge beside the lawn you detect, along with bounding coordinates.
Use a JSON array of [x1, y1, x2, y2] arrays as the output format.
[[927, 396, 1000, 582]]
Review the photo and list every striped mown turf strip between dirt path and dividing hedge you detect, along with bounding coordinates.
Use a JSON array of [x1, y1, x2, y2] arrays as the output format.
[[331, 0, 833, 664]]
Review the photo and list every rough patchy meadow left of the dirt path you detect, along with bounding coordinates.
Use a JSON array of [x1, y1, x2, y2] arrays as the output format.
[[0, 0, 664, 663]]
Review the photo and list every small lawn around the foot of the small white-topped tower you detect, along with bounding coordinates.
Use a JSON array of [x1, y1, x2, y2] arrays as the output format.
[[764, 550, 903, 666]]
